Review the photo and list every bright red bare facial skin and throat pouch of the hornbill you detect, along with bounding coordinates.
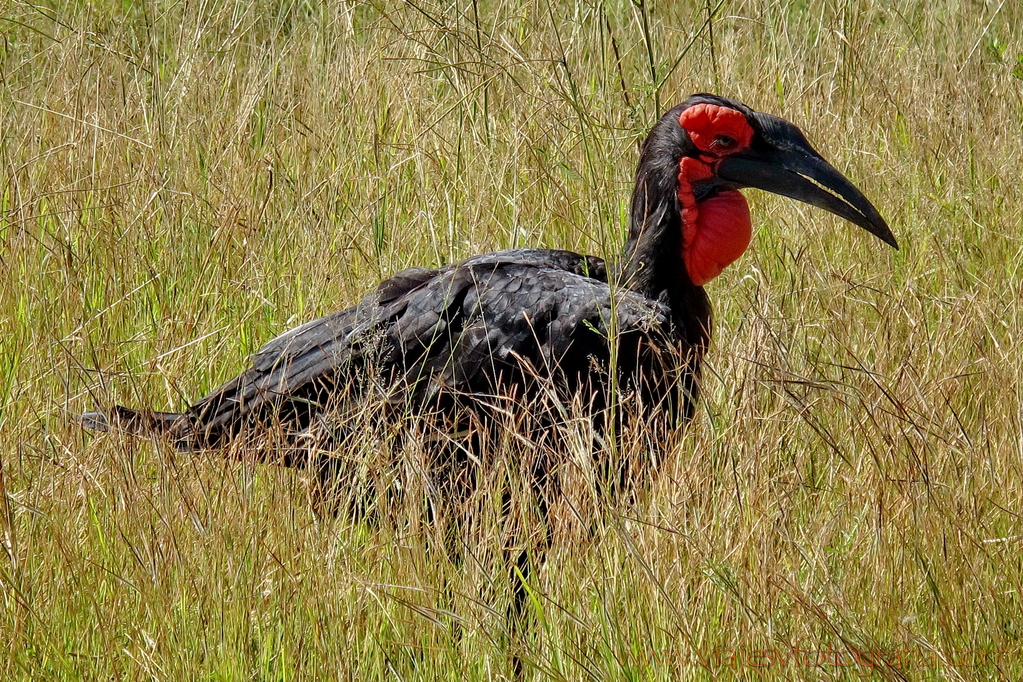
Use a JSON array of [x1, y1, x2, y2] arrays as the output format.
[[678, 104, 753, 286]]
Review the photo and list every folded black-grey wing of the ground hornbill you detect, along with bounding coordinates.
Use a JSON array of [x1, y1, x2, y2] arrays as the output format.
[[178, 249, 666, 445]]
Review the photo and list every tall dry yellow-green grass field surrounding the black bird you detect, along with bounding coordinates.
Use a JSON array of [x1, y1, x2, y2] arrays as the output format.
[[0, 0, 1023, 680]]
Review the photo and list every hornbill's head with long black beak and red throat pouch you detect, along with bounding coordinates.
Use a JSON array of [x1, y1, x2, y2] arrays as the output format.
[[633, 94, 898, 285]]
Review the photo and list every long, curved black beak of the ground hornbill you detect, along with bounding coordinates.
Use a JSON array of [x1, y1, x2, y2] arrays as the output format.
[[717, 126, 898, 248]]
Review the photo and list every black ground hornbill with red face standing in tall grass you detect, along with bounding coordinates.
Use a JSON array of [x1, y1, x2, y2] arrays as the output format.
[[82, 94, 897, 507]]
